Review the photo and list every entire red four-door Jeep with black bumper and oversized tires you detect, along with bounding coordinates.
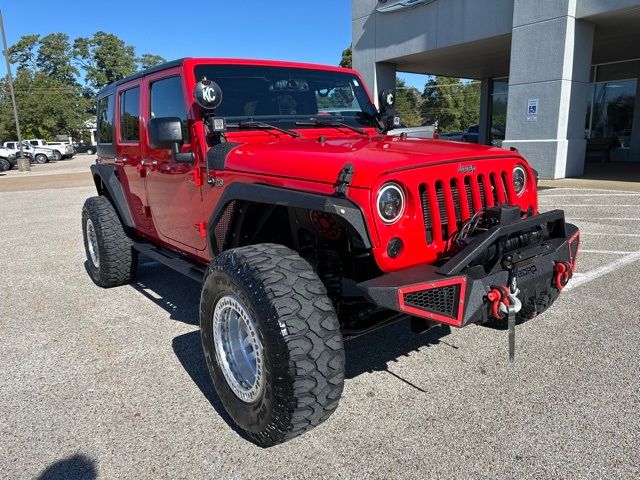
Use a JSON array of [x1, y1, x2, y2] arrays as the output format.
[[82, 58, 579, 446]]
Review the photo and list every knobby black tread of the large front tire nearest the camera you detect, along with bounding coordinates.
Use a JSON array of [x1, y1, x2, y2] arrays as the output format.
[[200, 244, 345, 447]]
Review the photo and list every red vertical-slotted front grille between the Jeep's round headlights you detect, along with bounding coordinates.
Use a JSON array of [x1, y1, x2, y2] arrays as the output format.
[[420, 172, 514, 244]]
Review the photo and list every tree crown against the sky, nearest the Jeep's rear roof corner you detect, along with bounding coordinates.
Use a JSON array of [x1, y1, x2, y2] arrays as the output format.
[[73, 32, 137, 90]]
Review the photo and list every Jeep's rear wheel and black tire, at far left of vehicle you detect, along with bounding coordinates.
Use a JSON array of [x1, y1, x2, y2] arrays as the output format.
[[82, 197, 138, 288]]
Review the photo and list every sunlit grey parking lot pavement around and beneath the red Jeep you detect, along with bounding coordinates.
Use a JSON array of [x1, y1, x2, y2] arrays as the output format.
[[0, 180, 640, 479]]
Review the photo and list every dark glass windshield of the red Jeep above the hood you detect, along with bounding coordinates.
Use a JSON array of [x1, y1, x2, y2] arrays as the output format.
[[195, 65, 376, 128]]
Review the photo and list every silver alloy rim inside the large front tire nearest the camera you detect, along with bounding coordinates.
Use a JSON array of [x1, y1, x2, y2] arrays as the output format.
[[213, 295, 264, 403]]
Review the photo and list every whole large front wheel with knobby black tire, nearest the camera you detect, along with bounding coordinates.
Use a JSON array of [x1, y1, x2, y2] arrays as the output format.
[[200, 244, 345, 447]]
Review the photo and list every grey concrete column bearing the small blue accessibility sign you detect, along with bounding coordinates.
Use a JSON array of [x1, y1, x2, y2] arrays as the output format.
[[504, 0, 594, 178]]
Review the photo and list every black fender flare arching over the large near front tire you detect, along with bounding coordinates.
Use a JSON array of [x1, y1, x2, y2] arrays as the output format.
[[207, 183, 372, 256]]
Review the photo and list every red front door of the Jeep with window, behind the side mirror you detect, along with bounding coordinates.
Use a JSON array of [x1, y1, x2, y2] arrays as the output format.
[[143, 67, 206, 253]]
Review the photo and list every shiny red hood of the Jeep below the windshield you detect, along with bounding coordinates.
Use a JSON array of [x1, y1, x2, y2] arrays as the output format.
[[226, 136, 517, 188]]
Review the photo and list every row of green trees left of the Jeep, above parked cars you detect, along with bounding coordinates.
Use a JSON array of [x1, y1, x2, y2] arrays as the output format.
[[0, 31, 165, 141]]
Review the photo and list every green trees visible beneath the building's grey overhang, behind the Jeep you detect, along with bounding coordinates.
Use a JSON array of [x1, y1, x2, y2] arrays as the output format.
[[340, 47, 480, 132]]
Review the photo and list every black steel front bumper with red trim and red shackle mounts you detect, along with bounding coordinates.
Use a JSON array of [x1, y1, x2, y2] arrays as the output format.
[[358, 210, 580, 327]]
